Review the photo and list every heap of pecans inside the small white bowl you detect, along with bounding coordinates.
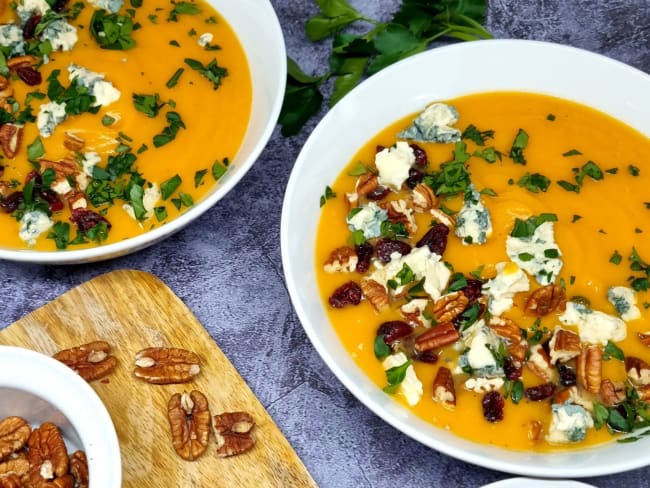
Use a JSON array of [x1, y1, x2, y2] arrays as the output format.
[[0, 417, 88, 488]]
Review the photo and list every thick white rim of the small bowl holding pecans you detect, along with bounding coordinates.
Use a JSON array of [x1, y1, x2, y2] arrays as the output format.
[[0, 345, 122, 488]]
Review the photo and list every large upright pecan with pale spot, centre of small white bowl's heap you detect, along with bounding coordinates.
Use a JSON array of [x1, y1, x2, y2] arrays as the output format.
[[27, 422, 70, 487]]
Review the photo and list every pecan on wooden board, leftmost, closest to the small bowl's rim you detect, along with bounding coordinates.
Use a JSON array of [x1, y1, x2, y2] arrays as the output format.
[[52, 341, 117, 381]]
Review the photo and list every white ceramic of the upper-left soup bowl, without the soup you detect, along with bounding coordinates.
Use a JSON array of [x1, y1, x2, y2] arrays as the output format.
[[0, 0, 287, 264]]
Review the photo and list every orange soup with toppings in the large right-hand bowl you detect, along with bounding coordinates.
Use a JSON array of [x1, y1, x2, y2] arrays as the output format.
[[316, 92, 650, 451]]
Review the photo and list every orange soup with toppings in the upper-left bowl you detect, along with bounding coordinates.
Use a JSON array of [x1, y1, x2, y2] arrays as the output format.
[[0, 0, 252, 251]]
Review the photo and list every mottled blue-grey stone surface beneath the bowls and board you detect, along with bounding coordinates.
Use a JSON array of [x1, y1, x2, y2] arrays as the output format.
[[0, 0, 650, 488]]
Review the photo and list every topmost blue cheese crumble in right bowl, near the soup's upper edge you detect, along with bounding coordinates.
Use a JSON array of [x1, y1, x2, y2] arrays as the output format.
[[397, 103, 461, 144]]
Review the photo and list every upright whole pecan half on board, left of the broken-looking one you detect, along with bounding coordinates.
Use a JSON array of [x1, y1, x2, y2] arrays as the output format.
[[167, 390, 210, 461]]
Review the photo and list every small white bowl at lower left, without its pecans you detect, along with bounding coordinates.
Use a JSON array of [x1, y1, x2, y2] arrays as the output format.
[[0, 346, 122, 488]]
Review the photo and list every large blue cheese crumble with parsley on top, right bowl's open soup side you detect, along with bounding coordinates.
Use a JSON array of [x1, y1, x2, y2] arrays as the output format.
[[506, 222, 563, 286]]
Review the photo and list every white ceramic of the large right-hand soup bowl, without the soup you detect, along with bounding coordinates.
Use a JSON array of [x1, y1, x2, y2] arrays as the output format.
[[281, 40, 650, 477]]
